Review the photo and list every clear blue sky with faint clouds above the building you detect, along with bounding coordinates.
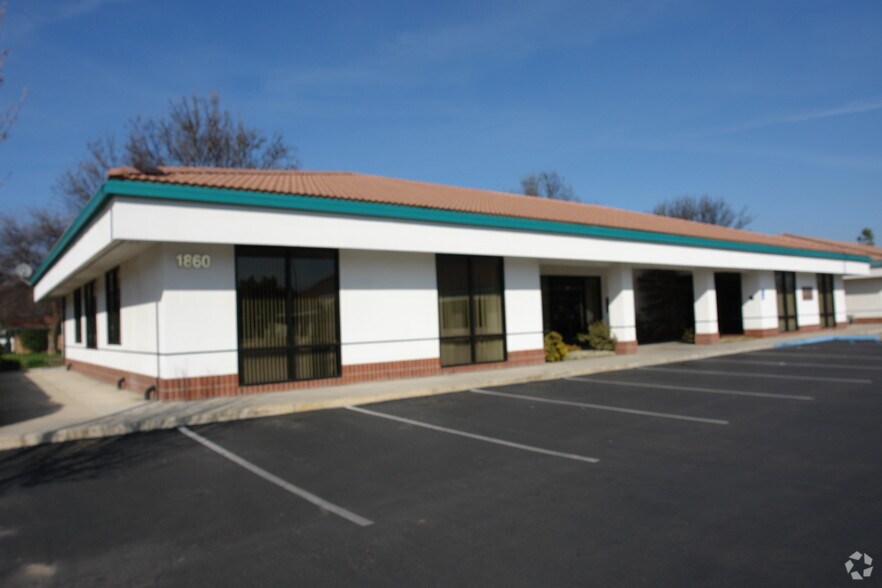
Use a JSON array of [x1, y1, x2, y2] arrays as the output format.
[[0, 0, 882, 240]]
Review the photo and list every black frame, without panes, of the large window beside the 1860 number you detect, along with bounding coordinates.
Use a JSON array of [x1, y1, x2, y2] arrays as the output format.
[[234, 245, 343, 386]]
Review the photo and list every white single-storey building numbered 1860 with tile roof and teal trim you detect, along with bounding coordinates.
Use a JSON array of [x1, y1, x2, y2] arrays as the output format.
[[32, 168, 870, 399]]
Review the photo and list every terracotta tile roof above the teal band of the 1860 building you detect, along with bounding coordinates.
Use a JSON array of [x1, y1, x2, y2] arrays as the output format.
[[107, 167, 850, 253]]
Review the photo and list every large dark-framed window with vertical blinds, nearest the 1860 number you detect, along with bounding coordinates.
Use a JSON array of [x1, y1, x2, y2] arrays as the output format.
[[236, 247, 340, 386]]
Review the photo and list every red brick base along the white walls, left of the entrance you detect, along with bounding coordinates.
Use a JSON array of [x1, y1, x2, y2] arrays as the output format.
[[67, 349, 545, 400]]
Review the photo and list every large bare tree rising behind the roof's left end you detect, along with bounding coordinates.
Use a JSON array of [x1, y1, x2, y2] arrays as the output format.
[[55, 93, 298, 211]]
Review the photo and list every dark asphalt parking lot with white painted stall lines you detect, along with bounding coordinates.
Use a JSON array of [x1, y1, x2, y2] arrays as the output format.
[[0, 342, 882, 586]]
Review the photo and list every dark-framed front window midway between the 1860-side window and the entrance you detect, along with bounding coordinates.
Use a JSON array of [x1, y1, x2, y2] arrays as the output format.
[[435, 255, 507, 367]]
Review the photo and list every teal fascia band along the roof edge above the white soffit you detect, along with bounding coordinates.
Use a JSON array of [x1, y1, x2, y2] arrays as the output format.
[[31, 180, 870, 285]]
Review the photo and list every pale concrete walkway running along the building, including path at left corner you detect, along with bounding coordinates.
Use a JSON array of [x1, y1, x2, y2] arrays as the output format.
[[0, 325, 882, 450]]
